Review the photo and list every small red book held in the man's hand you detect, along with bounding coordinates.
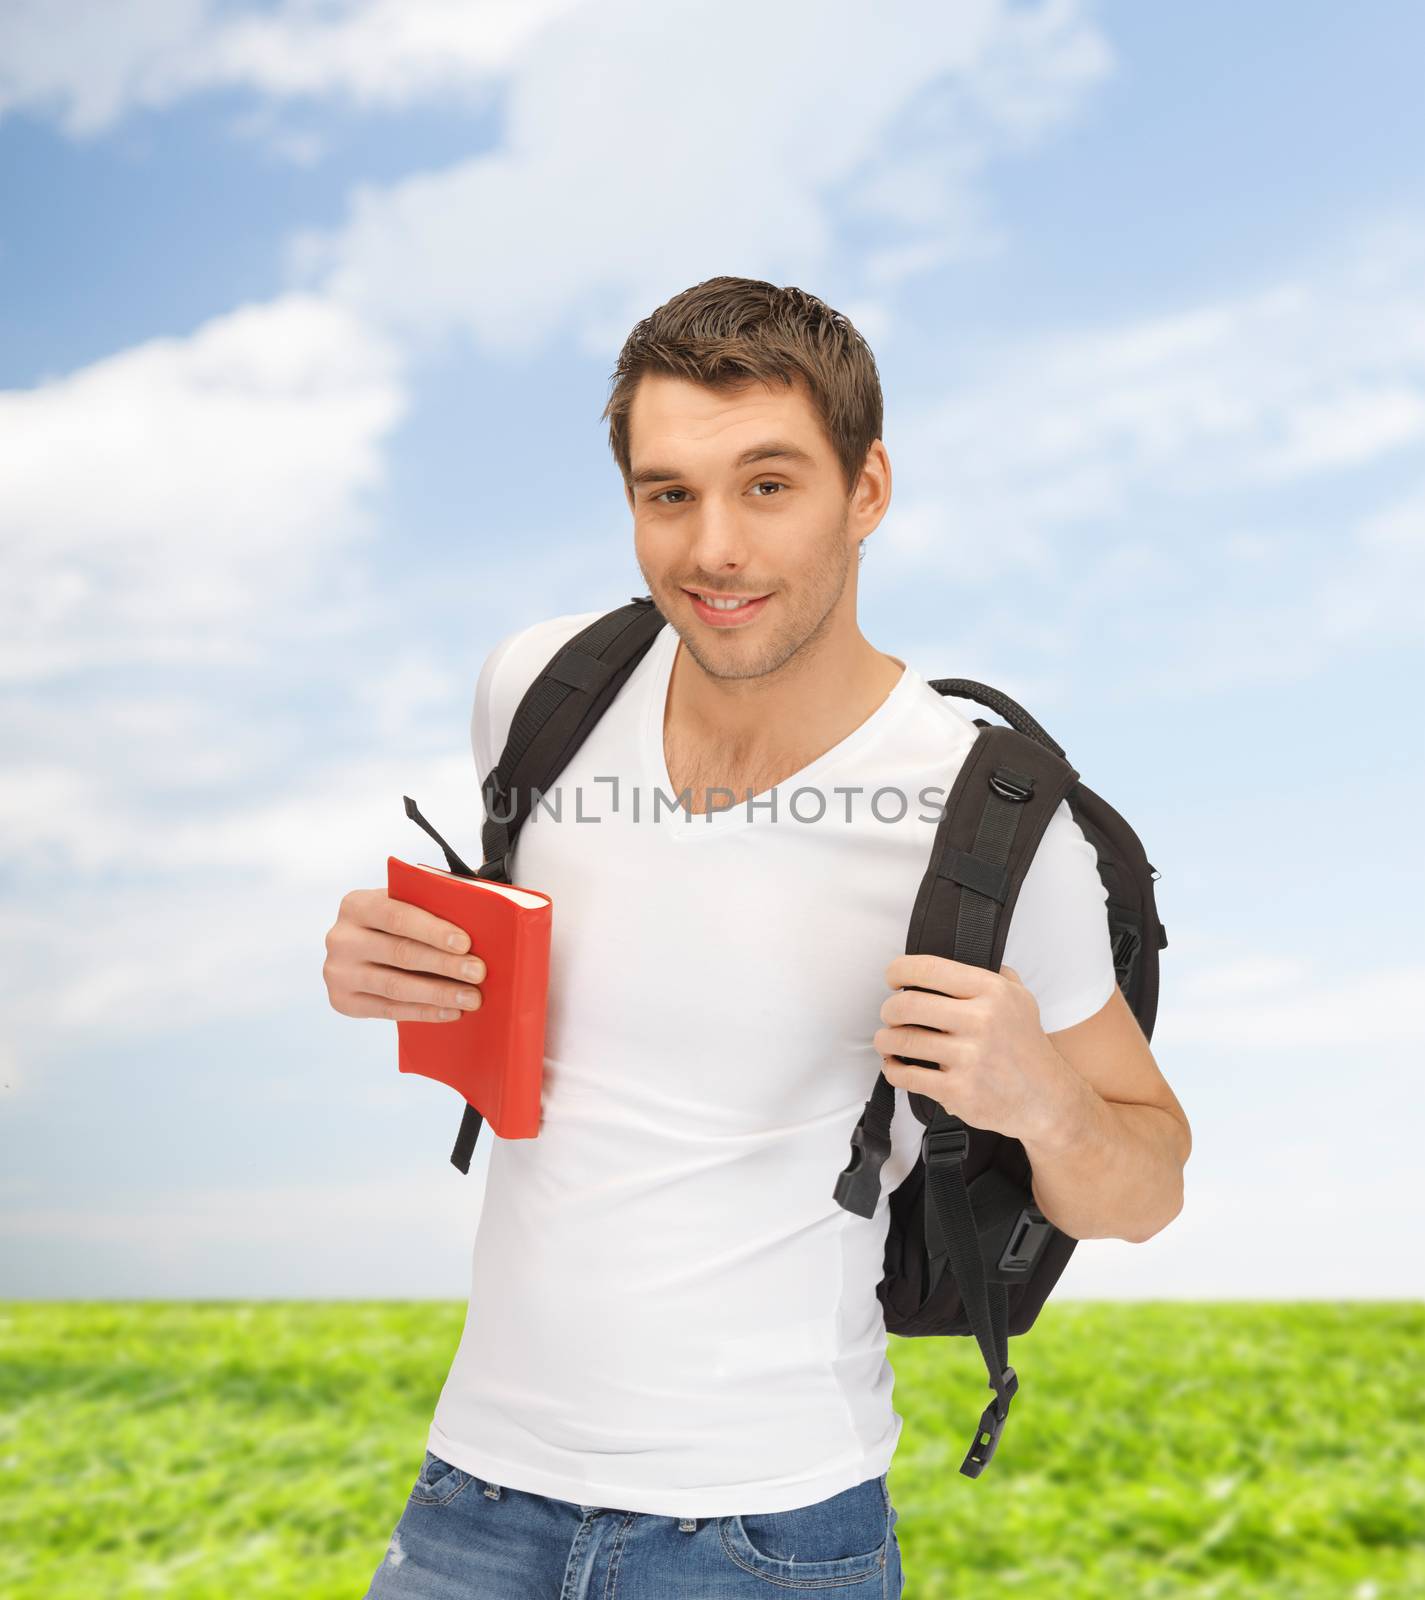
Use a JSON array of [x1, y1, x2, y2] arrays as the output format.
[[385, 856, 553, 1139]]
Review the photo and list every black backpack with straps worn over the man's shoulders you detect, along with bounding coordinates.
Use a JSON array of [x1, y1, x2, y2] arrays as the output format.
[[405, 595, 1168, 1478]]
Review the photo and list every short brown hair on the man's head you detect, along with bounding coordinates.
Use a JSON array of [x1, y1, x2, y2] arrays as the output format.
[[601, 277, 884, 498]]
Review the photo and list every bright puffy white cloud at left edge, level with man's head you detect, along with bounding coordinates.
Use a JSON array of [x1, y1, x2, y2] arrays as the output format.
[[0, 294, 406, 683]]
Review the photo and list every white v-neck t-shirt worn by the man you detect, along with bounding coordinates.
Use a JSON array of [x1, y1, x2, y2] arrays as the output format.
[[429, 611, 1115, 1517]]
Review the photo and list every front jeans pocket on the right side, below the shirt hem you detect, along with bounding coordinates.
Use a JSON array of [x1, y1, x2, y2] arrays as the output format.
[[718, 1474, 891, 1589]]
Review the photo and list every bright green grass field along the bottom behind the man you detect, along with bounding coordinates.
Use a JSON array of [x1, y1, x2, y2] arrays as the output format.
[[0, 1301, 1425, 1600]]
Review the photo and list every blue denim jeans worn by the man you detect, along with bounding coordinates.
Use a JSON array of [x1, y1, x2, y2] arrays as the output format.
[[366, 1450, 902, 1600]]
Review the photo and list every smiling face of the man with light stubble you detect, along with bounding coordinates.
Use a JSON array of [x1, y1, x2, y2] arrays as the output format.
[[629, 374, 881, 678]]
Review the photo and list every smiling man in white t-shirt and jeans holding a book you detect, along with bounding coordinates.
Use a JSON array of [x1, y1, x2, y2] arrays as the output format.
[[326, 278, 1190, 1600]]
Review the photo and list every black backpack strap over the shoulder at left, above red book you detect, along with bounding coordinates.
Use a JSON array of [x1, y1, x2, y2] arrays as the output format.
[[447, 595, 665, 1173]]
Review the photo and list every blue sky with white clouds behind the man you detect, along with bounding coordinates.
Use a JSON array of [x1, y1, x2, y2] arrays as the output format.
[[0, 0, 1425, 1298]]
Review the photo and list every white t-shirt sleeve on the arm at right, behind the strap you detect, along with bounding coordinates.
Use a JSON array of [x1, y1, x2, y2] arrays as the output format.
[[1003, 800, 1118, 1034]]
